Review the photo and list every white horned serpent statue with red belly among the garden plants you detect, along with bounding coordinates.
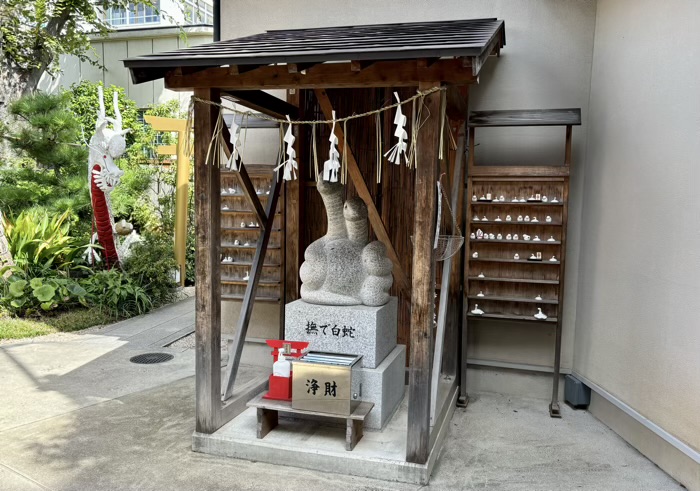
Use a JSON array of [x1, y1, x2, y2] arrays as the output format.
[[88, 87, 139, 269]]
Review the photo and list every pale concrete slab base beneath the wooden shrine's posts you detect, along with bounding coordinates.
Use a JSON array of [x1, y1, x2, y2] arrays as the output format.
[[192, 391, 457, 484]]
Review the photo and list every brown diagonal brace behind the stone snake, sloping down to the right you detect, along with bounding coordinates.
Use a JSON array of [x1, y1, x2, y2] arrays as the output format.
[[314, 89, 409, 290]]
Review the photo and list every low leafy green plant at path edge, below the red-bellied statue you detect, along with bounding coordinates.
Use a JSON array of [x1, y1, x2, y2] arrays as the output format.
[[81, 269, 153, 319]]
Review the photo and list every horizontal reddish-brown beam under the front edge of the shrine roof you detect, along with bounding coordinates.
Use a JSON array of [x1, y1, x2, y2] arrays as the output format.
[[165, 59, 476, 90]]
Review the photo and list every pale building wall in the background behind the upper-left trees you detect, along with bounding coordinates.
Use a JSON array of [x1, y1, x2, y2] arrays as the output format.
[[39, 26, 213, 107]]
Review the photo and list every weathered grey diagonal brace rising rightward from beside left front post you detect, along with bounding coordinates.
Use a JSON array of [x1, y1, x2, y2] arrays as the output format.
[[223, 168, 282, 401]]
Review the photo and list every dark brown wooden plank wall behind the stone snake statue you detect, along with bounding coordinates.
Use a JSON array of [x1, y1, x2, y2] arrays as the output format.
[[300, 88, 415, 364]]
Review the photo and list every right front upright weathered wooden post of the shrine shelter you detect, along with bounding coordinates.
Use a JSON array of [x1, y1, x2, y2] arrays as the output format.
[[406, 82, 440, 464]]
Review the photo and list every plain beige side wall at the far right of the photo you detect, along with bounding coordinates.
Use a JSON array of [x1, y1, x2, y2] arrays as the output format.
[[574, 0, 700, 472]]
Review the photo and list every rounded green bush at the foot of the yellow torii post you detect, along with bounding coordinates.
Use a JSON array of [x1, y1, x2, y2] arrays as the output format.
[[123, 234, 177, 307]]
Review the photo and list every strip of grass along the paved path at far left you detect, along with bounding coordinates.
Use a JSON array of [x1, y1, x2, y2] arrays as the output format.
[[0, 309, 115, 340]]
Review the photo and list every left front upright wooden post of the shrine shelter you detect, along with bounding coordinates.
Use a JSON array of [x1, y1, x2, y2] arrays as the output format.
[[194, 89, 221, 433]]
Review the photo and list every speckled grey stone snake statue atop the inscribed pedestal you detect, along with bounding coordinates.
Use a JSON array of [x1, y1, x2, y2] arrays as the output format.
[[299, 179, 393, 306]]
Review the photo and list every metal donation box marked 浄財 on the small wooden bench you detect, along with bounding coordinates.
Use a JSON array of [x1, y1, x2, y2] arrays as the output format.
[[292, 351, 362, 415]]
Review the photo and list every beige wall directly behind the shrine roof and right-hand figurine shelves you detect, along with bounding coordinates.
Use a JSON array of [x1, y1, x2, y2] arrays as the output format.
[[221, 0, 595, 376]]
